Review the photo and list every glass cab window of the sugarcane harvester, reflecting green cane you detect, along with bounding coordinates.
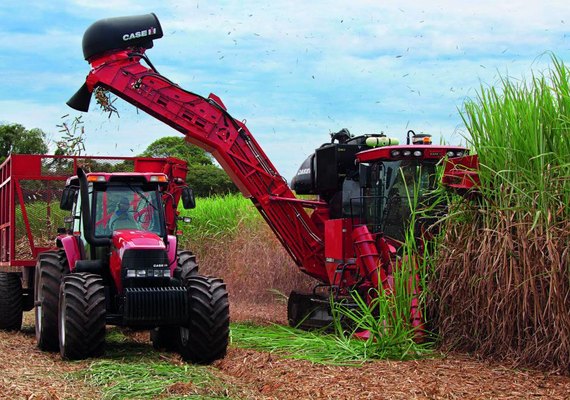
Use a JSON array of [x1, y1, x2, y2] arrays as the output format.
[[365, 160, 436, 241]]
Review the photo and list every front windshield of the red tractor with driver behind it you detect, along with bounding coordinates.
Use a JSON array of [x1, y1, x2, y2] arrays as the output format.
[[93, 185, 164, 236]]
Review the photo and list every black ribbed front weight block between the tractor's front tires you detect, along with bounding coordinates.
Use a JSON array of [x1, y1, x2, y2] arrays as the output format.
[[123, 286, 188, 325]]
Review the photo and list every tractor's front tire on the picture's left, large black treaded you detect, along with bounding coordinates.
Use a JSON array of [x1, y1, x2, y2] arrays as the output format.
[[58, 273, 105, 360]]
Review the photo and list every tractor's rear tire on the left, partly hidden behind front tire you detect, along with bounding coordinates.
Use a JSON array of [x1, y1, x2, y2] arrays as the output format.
[[34, 251, 68, 351]]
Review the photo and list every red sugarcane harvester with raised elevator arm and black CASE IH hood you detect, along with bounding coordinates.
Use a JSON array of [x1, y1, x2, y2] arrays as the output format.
[[63, 14, 474, 334]]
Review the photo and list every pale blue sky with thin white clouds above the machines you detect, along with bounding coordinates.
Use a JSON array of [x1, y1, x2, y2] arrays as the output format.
[[0, 0, 570, 180]]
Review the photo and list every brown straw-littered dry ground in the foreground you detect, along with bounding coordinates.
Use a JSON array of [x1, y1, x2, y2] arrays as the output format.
[[0, 304, 570, 400]]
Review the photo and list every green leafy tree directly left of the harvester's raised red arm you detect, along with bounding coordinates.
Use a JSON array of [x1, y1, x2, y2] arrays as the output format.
[[141, 136, 237, 197]]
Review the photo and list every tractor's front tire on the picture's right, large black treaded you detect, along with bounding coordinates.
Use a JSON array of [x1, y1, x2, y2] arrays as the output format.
[[178, 275, 230, 364]]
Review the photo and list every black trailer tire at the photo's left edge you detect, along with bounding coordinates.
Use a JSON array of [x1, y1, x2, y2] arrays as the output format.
[[0, 272, 24, 331]]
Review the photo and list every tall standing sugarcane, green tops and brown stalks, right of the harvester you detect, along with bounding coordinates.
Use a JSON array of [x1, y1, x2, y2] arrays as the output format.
[[432, 56, 570, 373]]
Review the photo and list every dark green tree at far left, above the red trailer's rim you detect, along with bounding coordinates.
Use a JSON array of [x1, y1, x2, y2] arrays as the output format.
[[0, 124, 48, 163]]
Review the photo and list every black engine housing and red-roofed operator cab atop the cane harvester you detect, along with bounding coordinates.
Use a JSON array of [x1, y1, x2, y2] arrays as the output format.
[[291, 129, 467, 241]]
